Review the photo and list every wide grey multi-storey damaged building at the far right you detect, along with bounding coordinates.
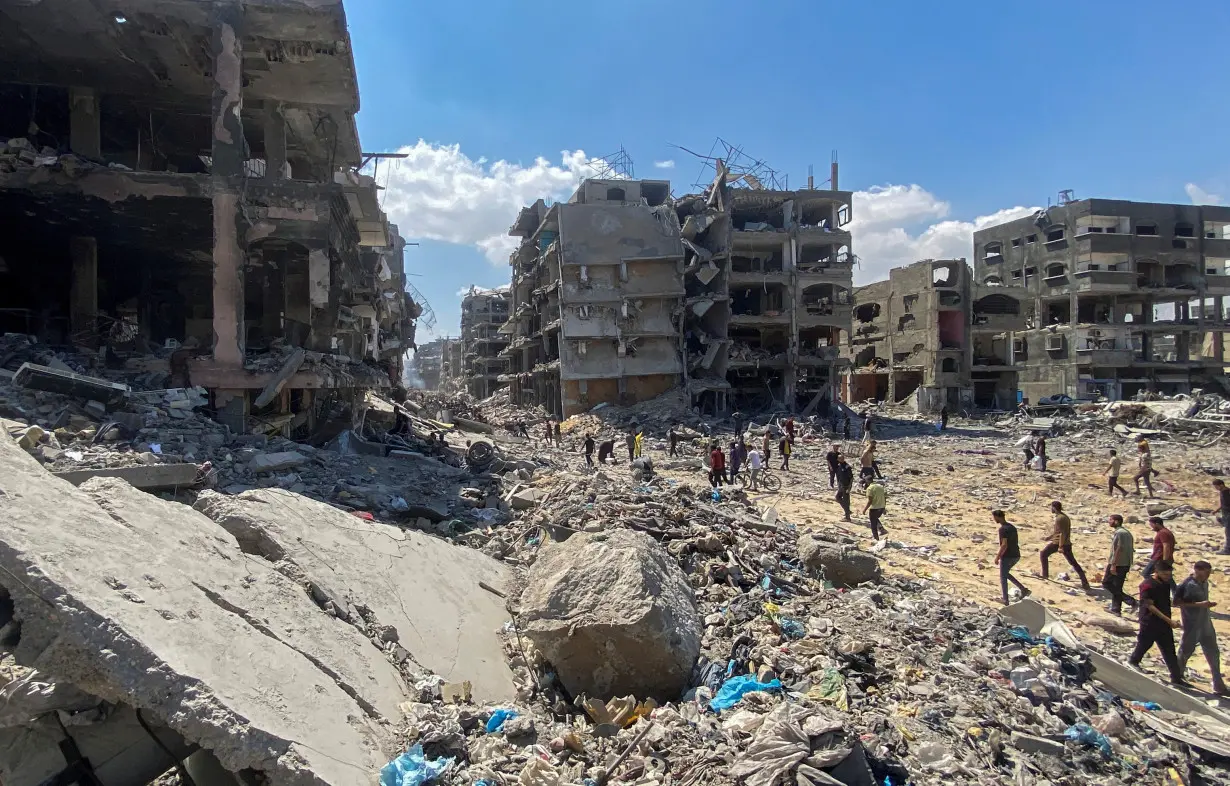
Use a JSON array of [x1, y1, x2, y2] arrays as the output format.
[[974, 199, 1230, 403]]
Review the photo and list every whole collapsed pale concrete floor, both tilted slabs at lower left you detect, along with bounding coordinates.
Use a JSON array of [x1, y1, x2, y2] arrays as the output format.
[[0, 439, 513, 786]]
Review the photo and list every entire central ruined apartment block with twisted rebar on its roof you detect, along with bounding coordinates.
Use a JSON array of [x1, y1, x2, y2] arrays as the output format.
[[502, 164, 854, 417]]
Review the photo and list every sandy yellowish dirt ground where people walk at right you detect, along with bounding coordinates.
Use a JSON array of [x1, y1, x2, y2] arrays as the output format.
[[644, 423, 1230, 689]]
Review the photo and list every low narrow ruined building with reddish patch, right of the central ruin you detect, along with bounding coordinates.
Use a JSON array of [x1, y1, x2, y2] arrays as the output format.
[[844, 260, 970, 411]]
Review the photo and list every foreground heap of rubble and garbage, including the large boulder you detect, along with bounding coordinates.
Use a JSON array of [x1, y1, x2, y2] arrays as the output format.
[[385, 470, 1230, 786]]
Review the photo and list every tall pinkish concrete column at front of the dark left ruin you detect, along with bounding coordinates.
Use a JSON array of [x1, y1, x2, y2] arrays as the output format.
[[210, 4, 246, 366]]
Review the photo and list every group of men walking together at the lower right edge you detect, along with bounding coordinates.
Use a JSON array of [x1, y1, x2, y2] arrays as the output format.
[[991, 487, 1230, 694]]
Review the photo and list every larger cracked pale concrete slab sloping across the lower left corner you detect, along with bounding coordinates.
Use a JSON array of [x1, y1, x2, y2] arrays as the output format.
[[0, 438, 408, 786]]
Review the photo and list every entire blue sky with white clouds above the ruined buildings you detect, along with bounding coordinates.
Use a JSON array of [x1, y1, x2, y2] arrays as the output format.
[[347, 0, 1230, 335]]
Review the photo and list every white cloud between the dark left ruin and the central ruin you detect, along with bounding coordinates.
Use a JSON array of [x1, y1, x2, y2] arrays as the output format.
[[378, 139, 601, 264]]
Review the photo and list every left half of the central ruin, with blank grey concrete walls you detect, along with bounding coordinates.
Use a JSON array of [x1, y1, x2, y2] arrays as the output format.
[[504, 180, 684, 417]]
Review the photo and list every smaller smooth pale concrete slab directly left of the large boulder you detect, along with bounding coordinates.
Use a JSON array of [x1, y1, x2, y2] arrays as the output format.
[[196, 488, 515, 701]]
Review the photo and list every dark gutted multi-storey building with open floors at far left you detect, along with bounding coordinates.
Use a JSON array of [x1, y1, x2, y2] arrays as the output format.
[[0, 0, 419, 432]]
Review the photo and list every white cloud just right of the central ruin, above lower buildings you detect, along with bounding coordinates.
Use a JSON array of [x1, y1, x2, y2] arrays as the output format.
[[850, 185, 1038, 285]]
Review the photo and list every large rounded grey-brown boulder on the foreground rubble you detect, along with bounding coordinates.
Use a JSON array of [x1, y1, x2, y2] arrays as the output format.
[[519, 529, 702, 700]]
